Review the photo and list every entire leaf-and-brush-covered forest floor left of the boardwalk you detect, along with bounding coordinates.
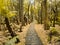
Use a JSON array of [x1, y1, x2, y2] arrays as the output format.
[[0, 23, 30, 45]]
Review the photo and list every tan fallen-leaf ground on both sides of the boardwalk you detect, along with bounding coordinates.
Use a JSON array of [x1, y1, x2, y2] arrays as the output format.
[[0, 23, 60, 45]]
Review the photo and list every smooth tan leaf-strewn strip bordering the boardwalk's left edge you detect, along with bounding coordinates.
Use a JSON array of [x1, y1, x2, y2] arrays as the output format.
[[16, 24, 30, 45]]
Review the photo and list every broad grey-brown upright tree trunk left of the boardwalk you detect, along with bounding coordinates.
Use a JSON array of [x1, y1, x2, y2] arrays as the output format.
[[19, 0, 25, 32]]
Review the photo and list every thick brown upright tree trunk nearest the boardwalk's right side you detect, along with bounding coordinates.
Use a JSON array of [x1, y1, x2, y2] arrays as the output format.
[[44, 0, 49, 30]]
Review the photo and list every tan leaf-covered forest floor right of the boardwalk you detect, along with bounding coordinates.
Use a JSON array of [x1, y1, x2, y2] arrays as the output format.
[[35, 24, 60, 45]]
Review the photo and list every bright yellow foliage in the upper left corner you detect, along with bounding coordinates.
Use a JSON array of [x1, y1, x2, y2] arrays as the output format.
[[0, 0, 16, 18]]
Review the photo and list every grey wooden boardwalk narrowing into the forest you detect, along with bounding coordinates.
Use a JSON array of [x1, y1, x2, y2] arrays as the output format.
[[25, 23, 43, 45]]
